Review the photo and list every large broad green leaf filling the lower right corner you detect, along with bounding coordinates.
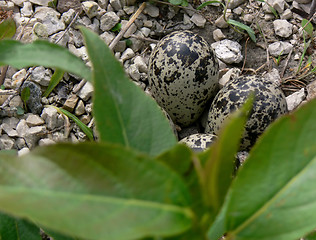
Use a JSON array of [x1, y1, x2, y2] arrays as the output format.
[[222, 100, 316, 240]]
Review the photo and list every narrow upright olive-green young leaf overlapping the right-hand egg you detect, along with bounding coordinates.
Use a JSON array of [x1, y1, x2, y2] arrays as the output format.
[[200, 95, 254, 217]]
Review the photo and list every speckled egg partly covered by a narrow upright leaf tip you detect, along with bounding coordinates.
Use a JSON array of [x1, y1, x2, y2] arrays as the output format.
[[205, 76, 287, 150]]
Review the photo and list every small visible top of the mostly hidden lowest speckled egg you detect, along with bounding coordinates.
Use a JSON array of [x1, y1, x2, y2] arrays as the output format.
[[180, 133, 217, 152]]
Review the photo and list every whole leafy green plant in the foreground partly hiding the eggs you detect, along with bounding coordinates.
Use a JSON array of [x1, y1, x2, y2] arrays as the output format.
[[0, 28, 316, 240]]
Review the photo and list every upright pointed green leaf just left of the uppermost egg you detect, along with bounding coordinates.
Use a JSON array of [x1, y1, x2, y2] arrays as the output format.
[[80, 28, 176, 156]]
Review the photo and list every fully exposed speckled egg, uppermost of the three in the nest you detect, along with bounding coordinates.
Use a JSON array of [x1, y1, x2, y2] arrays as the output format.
[[148, 31, 218, 126]]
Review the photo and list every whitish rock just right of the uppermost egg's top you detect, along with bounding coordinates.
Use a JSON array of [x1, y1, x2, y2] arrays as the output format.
[[211, 39, 243, 64]]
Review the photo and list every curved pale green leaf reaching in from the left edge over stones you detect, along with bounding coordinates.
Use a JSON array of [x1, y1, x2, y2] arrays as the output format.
[[0, 40, 91, 81]]
